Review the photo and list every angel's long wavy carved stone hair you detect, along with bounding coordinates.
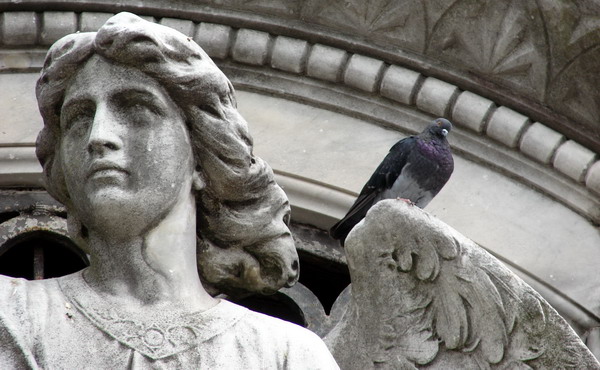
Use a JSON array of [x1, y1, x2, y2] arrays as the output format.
[[36, 13, 298, 294]]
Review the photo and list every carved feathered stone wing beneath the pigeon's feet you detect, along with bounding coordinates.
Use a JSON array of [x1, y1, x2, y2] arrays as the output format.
[[325, 200, 600, 369]]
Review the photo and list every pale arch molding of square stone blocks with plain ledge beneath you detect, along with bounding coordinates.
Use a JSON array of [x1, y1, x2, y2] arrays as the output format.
[[0, 7, 600, 223]]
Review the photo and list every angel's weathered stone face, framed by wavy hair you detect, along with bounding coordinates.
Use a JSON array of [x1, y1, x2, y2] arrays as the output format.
[[60, 56, 194, 238]]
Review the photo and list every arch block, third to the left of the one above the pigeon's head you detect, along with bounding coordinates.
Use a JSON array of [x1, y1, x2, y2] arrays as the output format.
[[306, 44, 348, 82]]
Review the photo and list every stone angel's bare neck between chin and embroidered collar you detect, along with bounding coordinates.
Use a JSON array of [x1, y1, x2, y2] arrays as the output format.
[[84, 194, 215, 311]]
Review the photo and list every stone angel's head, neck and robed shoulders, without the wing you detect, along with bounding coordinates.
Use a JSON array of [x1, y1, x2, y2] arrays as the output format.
[[0, 13, 338, 369]]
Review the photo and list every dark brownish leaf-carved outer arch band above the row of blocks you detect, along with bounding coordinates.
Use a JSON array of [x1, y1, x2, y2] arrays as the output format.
[[0, 0, 600, 152]]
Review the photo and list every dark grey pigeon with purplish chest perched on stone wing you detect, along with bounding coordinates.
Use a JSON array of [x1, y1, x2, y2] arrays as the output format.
[[329, 118, 454, 246]]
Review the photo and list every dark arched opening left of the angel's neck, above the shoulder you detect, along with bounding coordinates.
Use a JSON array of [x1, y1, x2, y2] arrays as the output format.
[[0, 231, 88, 280]]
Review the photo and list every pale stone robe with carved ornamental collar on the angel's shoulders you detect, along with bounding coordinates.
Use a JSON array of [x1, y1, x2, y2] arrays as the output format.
[[0, 272, 338, 369]]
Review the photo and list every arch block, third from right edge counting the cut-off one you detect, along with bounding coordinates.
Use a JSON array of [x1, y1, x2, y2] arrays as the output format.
[[519, 122, 565, 164]]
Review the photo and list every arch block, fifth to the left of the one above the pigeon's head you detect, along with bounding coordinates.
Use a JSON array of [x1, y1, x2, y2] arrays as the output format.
[[231, 29, 269, 65]]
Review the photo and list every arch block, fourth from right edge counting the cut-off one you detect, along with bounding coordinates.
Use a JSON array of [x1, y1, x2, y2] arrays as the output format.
[[486, 107, 529, 148]]
